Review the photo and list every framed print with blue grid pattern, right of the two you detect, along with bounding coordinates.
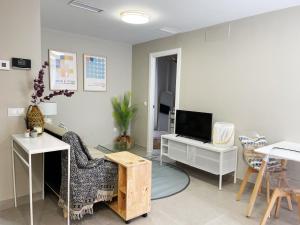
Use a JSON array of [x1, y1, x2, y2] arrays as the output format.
[[83, 54, 106, 91]]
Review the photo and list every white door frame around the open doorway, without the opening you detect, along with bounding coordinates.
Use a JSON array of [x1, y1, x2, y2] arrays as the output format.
[[147, 48, 181, 153]]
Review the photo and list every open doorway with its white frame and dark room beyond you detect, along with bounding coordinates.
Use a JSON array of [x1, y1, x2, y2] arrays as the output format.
[[147, 49, 181, 152]]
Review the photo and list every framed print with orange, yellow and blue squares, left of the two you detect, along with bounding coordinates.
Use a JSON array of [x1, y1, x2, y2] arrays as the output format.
[[49, 50, 77, 91]]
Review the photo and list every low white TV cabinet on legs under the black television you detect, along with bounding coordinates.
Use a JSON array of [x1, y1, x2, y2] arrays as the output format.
[[160, 134, 237, 190]]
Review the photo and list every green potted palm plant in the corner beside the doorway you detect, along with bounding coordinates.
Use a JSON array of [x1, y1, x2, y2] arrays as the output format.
[[111, 92, 137, 150]]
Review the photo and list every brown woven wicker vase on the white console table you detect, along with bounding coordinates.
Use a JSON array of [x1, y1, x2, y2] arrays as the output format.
[[26, 105, 45, 132]]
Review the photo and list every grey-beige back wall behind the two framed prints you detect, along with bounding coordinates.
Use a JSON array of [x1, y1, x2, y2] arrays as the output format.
[[42, 29, 132, 146]]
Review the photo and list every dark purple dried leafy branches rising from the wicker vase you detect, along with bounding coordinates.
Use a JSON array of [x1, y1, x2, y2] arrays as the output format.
[[31, 62, 74, 105]]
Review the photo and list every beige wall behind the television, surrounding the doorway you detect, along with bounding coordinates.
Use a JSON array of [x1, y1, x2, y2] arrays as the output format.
[[132, 7, 300, 184]]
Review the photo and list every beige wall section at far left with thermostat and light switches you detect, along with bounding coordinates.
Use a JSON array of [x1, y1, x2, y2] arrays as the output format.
[[0, 0, 41, 205]]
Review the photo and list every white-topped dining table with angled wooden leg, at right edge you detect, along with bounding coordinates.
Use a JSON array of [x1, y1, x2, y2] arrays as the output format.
[[247, 141, 300, 222]]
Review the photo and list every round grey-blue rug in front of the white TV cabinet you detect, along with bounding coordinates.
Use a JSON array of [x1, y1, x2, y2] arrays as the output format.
[[151, 160, 190, 200]]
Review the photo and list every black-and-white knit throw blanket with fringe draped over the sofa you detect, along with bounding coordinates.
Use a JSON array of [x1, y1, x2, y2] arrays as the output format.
[[58, 132, 118, 220]]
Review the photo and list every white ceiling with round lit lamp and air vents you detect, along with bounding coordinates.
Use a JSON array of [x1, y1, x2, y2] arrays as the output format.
[[41, 0, 300, 44]]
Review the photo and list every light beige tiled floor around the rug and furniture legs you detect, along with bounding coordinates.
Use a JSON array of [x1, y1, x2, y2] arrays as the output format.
[[0, 150, 299, 225]]
